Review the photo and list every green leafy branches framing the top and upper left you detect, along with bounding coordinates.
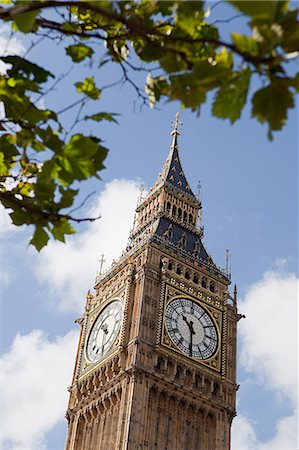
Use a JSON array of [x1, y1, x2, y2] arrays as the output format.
[[0, 0, 299, 250]]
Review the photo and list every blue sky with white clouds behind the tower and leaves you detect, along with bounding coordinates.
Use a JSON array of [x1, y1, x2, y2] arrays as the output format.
[[0, 3, 299, 450]]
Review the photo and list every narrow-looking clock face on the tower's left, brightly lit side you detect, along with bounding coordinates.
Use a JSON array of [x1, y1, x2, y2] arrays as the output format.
[[86, 300, 122, 362]]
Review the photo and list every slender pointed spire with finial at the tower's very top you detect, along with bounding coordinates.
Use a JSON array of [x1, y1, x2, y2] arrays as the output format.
[[157, 112, 194, 196]]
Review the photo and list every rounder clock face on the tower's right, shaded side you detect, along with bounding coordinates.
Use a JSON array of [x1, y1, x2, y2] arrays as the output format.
[[165, 298, 218, 360]]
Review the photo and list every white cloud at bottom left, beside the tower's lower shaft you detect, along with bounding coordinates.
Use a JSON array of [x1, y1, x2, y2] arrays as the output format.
[[1, 330, 78, 450]]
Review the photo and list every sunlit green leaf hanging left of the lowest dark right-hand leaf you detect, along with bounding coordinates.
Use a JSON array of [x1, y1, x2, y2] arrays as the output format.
[[212, 69, 251, 123]]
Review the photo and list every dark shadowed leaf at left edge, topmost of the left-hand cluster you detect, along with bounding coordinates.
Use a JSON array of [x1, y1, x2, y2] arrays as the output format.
[[0, 55, 54, 83]]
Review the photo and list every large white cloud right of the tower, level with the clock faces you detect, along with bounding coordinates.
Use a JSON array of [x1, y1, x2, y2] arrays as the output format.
[[239, 270, 299, 404]]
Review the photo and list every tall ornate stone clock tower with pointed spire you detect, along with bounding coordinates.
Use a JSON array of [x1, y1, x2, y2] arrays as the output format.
[[66, 115, 238, 450]]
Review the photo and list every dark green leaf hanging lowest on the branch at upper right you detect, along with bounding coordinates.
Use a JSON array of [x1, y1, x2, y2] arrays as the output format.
[[252, 79, 294, 131]]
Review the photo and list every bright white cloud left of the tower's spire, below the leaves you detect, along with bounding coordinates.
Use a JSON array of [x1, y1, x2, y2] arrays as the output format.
[[35, 180, 139, 313]]
